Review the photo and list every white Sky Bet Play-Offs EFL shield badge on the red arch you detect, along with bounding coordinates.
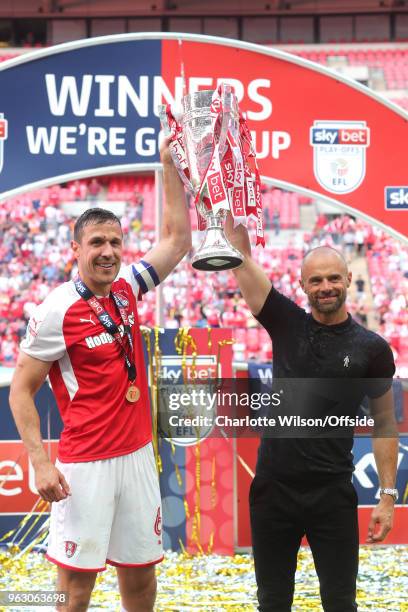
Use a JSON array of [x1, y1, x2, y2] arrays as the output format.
[[310, 121, 370, 193]]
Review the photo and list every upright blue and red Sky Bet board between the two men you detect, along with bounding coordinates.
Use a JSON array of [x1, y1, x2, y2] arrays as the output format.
[[147, 328, 234, 555]]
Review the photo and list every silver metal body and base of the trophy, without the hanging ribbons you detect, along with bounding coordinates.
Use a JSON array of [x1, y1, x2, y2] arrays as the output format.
[[160, 87, 244, 271]]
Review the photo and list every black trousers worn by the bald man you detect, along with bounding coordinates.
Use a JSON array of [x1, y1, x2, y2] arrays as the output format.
[[249, 475, 359, 612]]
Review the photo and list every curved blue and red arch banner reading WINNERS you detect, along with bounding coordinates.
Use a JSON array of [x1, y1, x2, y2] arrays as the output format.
[[0, 33, 408, 239]]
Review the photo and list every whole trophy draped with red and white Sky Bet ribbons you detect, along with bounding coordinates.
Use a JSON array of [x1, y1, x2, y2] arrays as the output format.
[[159, 84, 265, 269]]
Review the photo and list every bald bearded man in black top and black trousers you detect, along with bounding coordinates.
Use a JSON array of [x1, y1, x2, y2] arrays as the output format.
[[226, 220, 398, 612]]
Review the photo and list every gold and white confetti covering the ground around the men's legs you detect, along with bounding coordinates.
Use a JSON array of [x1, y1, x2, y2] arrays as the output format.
[[0, 546, 408, 612]]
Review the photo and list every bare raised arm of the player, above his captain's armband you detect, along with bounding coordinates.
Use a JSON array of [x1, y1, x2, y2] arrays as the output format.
[[143, 140, 191, 281]]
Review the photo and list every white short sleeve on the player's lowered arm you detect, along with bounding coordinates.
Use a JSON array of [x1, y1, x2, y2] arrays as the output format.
[[20, 300, 66, 361]]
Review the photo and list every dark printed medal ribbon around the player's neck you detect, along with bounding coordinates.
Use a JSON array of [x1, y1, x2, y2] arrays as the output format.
[[74, 277, 136, 382]]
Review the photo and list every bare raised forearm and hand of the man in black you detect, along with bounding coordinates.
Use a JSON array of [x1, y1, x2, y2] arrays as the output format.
[[225, 214, 272, 315]]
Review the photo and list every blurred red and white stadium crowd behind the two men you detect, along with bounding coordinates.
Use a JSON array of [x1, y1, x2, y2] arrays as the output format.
[[0, 180, 408, 366]]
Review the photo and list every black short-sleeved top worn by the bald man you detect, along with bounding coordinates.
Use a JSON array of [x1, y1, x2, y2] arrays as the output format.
[[256, 288, 395, 481]]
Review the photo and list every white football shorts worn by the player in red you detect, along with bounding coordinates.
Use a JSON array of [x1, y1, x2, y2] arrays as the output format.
[[46, 443, 163, 572]]
